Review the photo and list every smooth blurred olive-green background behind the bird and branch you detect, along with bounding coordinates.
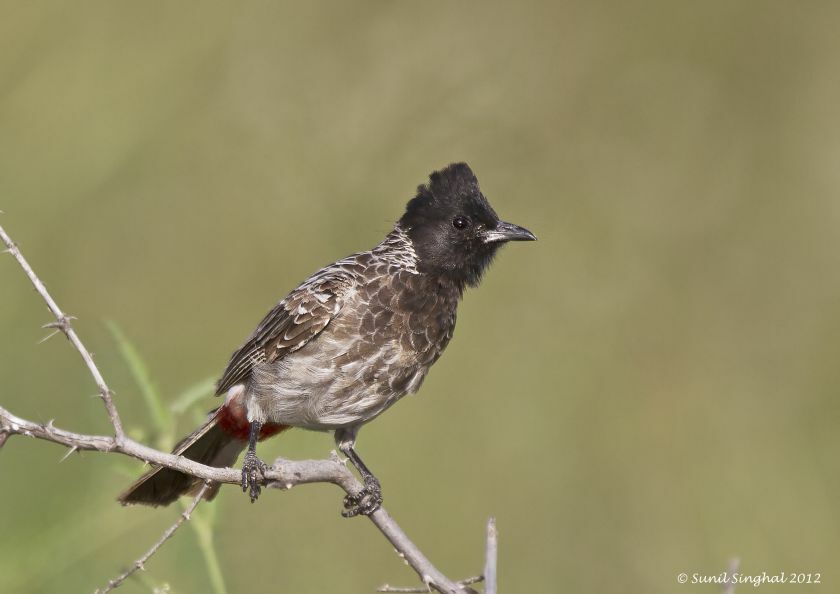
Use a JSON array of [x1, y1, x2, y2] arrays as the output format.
[[0, 1, 840, 593]]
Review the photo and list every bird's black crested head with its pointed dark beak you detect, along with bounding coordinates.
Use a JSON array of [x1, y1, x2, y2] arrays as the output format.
[[400, 163, 536, 286]]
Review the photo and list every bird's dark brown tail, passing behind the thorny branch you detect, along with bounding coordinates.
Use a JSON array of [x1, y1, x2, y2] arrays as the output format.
[[117, 415, 246, 507]]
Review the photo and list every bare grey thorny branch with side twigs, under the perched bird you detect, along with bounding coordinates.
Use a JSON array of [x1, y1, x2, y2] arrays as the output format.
[[0, 220, 488, 594]]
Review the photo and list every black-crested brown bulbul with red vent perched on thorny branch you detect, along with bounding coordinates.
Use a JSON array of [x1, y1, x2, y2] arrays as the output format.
[[118, 163, 536, 517]]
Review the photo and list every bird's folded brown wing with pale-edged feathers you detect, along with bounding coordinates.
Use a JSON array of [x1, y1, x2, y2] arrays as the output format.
[[216, 267, 352, 395]]
